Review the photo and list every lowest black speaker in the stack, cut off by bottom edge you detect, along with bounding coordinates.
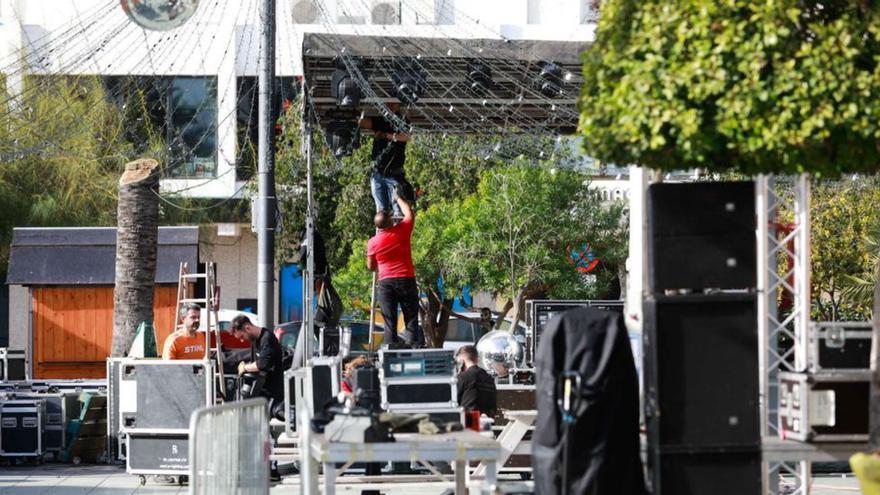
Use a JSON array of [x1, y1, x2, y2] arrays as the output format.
[[649, 449, 762, 495]]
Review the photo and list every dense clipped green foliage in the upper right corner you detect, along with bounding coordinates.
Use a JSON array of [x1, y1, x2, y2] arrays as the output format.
[[579, 0, 880, 176]]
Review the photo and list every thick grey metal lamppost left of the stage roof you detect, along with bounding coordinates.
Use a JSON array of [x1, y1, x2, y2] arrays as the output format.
[[257, 0, 276, 328]]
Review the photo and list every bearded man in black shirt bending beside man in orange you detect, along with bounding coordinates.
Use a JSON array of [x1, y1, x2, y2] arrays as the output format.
[[232, 315, 284, 421]]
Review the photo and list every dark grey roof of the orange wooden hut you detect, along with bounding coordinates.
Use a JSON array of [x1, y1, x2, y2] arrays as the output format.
[[6, 227, 199, 285]]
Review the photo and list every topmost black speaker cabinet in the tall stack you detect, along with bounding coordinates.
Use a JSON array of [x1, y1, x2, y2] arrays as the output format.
[[647, 181, 757, 292]]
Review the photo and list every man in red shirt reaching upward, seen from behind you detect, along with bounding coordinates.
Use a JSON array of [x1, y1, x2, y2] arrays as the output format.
[[367, 193, 424, 347]]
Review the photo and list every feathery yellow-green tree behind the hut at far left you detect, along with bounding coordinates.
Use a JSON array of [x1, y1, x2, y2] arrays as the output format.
[[0, 76, 146, 267]]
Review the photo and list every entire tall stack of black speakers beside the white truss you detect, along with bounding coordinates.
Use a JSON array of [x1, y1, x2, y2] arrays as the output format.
[[644, 182, 761, 495]]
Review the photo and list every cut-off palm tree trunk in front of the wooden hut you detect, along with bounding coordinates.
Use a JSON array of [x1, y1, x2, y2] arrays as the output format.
[[111, 159, 159, 357]]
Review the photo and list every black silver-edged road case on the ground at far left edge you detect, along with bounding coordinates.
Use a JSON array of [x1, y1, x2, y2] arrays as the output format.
[[0, 399, 46, 458]]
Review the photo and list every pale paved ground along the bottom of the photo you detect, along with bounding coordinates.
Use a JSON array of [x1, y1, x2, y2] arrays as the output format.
[[0, 464, 860, 495]]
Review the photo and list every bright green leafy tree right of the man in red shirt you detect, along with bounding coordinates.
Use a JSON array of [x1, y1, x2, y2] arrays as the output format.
[[449, 165, 626, 328]]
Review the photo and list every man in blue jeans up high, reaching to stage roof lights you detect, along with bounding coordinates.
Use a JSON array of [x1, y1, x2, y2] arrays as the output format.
[[360, 102, 413, 222]]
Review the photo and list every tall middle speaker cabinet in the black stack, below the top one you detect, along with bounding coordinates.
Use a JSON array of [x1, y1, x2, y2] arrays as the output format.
[[643, 293, 760, 448]]
